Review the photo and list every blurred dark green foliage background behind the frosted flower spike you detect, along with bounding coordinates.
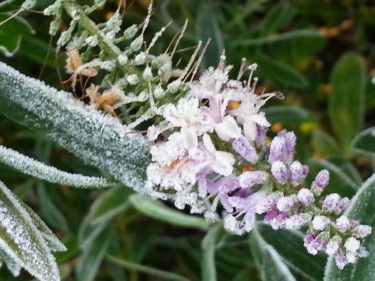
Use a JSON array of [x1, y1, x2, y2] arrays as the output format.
[[0, 0, 375, 281]]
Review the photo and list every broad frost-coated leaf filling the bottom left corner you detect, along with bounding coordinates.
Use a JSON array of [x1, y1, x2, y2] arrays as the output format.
[[0, 179, 60, 281]]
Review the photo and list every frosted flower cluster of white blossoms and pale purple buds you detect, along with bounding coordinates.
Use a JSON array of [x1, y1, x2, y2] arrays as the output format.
[[146, 55, 372, 268]]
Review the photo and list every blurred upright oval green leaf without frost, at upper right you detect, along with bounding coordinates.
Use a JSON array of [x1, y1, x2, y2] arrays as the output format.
[[328, 54, 366, 158]]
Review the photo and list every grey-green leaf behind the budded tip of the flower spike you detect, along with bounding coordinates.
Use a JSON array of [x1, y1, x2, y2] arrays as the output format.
[[324, 174, 375, 281]]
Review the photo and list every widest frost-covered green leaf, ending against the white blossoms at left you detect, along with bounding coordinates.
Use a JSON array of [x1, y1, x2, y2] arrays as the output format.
[[0, 63, 151, 193]]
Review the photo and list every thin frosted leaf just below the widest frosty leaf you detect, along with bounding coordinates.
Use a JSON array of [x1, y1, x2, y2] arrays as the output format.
[[0, 145, 112, 188]]
